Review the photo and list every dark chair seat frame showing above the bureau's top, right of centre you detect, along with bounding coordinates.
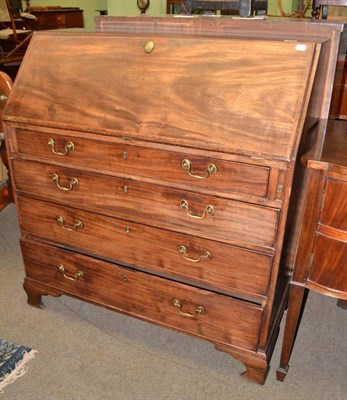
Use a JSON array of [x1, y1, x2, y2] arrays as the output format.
[[182, 0, 267, 17]]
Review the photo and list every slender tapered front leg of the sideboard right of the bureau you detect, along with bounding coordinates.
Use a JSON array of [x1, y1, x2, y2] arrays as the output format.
[[276, 284, 305, 382]]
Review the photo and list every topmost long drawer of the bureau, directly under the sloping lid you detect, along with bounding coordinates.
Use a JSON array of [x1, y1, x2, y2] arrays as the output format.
[[16, 129, 270, 198]]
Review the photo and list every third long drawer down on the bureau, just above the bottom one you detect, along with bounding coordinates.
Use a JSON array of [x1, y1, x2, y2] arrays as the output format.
[[18, 198, 272, 301]]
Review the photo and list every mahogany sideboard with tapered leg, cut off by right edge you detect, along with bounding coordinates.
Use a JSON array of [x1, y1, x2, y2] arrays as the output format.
[[277, 120, 347, 381]]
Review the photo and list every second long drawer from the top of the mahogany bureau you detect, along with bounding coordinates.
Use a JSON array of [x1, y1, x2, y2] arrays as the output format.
[[14, 160, 278, 248]]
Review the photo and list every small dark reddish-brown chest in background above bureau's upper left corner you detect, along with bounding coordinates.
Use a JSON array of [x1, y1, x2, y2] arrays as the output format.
[[31, 7, 84, 31]]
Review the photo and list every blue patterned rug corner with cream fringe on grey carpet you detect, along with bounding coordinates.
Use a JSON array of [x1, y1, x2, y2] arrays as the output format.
[[0, 338, 37, 393]]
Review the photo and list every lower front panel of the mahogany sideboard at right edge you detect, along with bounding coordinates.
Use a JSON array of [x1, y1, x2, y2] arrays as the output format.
[[308, 234, 347, 297]]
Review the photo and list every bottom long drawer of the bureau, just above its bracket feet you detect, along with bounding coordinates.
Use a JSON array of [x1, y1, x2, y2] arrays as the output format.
[[22, 238, 262, 350]]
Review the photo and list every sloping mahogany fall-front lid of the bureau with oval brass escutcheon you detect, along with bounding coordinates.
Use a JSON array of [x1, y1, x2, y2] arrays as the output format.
[[4, 32, 319, 160]]
